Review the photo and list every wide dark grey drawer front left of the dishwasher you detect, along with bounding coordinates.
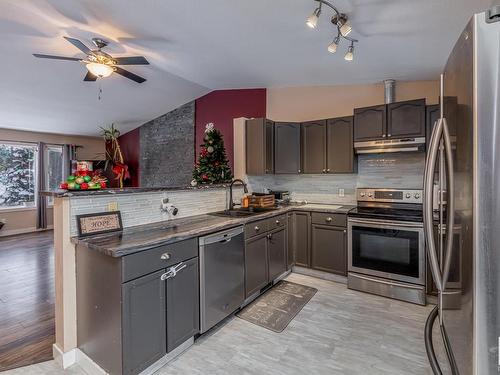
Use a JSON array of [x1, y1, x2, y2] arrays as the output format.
[[122, 238, 198, 282]]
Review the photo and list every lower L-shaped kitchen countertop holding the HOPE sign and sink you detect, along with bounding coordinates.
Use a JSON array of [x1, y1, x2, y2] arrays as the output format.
[[71, 203, 354, 257]]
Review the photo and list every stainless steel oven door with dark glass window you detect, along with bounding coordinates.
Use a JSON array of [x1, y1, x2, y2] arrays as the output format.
[[348, 218, 425, 285]]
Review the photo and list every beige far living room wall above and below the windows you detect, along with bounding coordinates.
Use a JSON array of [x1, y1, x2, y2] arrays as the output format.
[[0, 128, 104, 236]]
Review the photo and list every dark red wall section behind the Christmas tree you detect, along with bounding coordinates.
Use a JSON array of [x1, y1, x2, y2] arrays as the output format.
[[195, 89, 266, 168]]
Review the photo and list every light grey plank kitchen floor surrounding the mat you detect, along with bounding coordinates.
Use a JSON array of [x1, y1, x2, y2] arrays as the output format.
[[2, 274, 449, 375]]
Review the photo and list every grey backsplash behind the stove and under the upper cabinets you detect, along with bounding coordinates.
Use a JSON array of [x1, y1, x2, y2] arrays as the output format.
[[247, 152, 425, 204]]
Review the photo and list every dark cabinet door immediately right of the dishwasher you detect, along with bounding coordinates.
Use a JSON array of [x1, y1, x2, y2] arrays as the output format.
[[245, 233, 268, 297]]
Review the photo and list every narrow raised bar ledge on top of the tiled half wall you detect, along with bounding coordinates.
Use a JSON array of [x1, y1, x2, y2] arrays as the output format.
[[40, 184, 241, 198]]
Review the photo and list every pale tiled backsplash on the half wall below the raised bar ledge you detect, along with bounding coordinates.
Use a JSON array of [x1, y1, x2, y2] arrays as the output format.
[[70, 186, 243, 236]]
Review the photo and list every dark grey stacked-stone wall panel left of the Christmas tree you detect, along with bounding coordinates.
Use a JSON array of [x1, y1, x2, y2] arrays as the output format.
[[139, 101, 195, 187]]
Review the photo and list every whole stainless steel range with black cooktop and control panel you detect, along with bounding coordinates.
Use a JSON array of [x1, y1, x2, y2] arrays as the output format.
[[347, 189, 427, 305]]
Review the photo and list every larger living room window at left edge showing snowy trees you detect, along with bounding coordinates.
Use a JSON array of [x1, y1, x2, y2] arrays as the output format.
[[0, 143, 37, 208]]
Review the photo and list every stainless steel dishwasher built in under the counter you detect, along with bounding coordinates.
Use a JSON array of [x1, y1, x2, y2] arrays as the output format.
[[199, 226, 245, 333]]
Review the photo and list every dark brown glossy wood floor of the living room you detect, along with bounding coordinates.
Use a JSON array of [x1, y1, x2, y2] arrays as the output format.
[[0, 231, 55, 371]]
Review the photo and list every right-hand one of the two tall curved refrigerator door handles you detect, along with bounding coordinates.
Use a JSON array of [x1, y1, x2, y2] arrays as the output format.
[[442, 118, 455, 290]]
